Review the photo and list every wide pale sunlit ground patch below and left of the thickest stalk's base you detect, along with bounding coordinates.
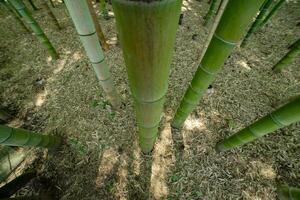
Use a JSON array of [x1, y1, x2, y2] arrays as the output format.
[[95, 148, 119, 188]]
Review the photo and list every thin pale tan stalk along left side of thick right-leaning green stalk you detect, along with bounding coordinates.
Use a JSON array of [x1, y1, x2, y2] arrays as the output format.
[[199, 0, 228, 61]]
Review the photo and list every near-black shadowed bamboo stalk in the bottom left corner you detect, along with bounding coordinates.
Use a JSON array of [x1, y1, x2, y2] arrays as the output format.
[[0, 171, 36, 199]]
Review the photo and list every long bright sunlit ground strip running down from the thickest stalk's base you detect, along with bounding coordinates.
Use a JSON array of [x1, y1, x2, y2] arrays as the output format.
[[150, 123, 175, 199]]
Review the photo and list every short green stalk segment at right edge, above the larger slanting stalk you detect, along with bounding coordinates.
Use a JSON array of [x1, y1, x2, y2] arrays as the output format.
[[272, 39, 300, 72]]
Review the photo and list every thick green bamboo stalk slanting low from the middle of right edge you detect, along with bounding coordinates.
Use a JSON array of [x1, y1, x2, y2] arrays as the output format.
[[216, 96, 300, 151]]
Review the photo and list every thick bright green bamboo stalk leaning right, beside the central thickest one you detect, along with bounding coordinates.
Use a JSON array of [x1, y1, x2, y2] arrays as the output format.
[[172, 0, 263, 128]]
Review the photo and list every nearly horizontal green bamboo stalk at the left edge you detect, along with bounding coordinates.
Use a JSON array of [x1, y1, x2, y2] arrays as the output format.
[[0, 125, 61, 149]]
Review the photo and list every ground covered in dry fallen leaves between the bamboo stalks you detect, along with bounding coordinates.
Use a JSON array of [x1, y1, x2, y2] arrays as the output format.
[[0, 0, 300, 200]]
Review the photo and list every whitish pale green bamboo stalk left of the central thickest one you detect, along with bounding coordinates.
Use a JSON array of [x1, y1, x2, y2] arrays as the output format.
[[65, 0, 120, 108]]
